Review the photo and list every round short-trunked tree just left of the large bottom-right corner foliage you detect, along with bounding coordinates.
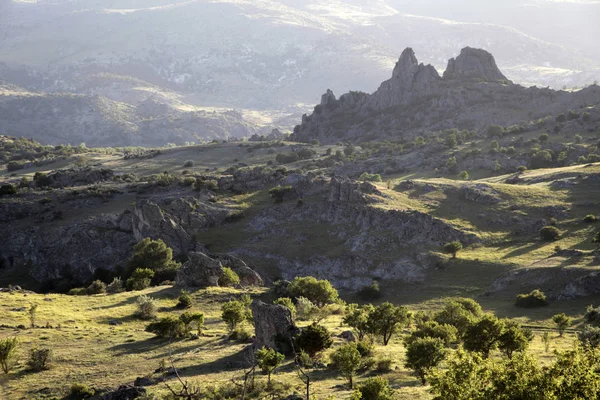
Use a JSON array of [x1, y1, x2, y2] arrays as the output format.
[[404, 337, 446, 385]]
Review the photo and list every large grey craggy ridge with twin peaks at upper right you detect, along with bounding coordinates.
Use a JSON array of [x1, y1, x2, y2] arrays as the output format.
[[291, 47, 600, 143]]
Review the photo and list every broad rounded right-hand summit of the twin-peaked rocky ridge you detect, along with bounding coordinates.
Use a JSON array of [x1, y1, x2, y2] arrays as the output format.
[[444, 47, 508, 81]]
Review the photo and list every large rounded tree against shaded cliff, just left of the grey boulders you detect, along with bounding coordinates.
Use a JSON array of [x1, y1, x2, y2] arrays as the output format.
[[128, 238, 180, 280]]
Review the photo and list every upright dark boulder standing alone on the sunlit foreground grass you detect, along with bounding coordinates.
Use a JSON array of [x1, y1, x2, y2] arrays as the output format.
[[252, 300, 299, 355]]
